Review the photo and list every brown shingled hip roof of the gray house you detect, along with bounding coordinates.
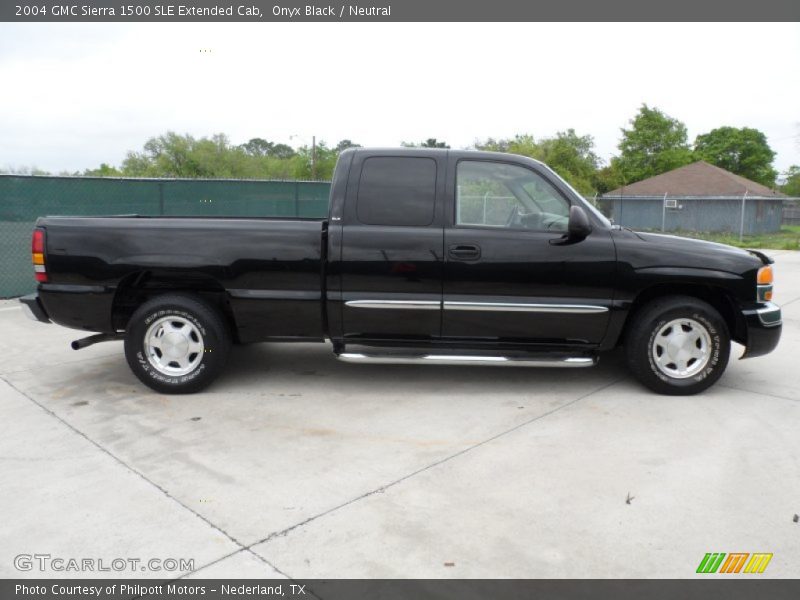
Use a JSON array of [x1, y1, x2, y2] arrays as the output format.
[[603, 160, 785, 198]]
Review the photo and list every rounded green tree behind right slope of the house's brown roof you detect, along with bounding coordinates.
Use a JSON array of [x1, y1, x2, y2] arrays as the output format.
[[694, 127, 778, 187]]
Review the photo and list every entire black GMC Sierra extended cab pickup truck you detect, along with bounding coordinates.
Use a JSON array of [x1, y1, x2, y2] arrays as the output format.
[[22, 149, 781, 394]]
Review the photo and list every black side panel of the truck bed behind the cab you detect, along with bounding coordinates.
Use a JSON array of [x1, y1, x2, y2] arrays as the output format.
[[37, 217, 325, 341]]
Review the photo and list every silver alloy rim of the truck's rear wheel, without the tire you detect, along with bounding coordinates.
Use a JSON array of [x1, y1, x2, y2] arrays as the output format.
[[144, 316, 205, 376]]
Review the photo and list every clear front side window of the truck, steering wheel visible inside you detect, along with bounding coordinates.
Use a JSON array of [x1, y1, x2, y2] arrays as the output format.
[[456, 160, 569, 232]]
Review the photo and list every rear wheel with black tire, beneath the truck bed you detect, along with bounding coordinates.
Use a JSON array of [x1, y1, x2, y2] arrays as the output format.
[[125, 294, 231, 394]]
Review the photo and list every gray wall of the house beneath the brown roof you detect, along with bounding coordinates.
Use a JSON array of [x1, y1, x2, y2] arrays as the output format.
[[597, 196, 783, 235]]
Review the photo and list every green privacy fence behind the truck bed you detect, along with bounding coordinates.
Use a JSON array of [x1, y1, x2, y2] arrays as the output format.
[[0, 175, 330, 298]]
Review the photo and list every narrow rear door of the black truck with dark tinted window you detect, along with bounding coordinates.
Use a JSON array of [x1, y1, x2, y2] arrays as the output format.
[[339, 151, 447, 342]]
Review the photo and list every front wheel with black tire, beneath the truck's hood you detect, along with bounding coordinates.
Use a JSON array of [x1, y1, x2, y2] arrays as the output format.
[[625, 296, 731, 396]]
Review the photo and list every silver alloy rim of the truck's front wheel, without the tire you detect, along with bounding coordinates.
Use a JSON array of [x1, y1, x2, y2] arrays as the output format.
[[650, 319, 711, 379]]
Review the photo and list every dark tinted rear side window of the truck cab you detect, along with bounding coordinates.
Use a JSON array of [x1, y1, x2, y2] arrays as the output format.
[[356, 156, 436, 227]]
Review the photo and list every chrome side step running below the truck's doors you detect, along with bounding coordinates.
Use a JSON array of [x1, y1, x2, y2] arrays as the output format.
[[336, 352, 597, 368]]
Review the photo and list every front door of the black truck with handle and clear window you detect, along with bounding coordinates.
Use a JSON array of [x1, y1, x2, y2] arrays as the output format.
[[442, 154, 615, 346]]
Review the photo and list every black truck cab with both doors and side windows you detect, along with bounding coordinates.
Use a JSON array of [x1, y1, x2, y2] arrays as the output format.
[[327, 149, 616, 356]]
